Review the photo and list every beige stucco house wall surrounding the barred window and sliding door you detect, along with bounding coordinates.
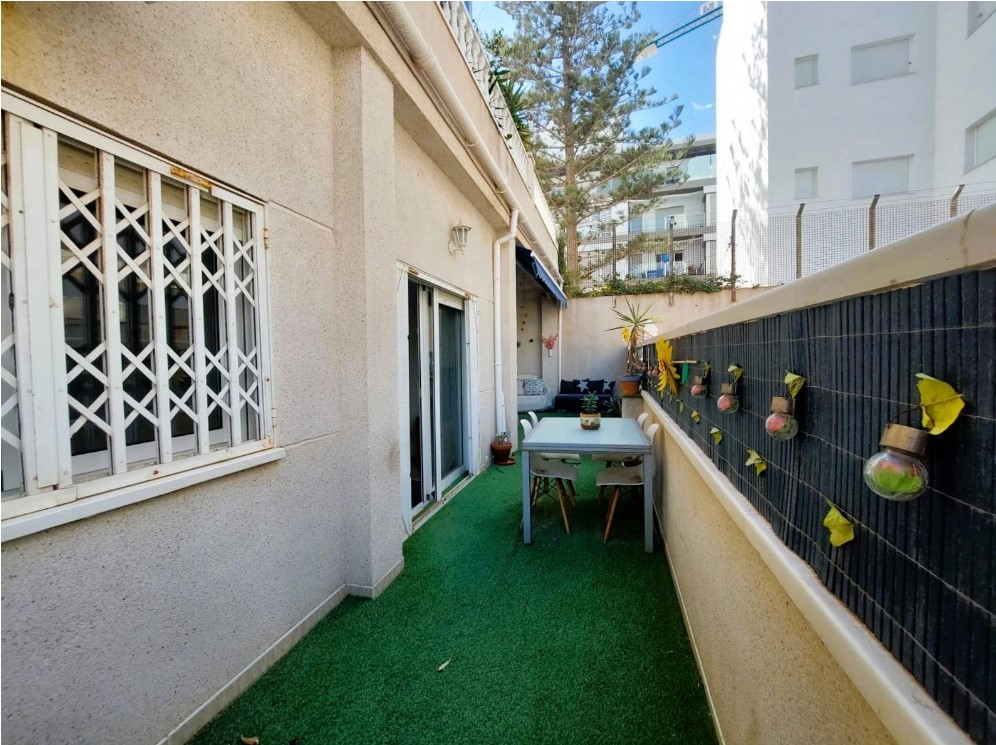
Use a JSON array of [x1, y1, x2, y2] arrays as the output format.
[[2, 3, 555, 745]]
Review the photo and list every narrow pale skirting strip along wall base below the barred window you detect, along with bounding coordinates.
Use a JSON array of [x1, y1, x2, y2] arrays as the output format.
[[158, 585, 348, 745]]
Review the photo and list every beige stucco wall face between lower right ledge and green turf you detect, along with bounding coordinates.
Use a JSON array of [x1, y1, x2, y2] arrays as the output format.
[[640, 402, 895, 745]]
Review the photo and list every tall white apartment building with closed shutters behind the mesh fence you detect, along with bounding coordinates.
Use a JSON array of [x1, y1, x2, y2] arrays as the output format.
[[716, 2, 996, 284]]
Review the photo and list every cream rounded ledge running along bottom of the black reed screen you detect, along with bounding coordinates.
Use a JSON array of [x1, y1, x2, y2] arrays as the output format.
[[643, 392, 972, 745]]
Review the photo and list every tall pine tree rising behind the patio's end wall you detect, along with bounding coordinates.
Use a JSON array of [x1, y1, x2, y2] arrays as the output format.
[[498, 2, 691, 279]]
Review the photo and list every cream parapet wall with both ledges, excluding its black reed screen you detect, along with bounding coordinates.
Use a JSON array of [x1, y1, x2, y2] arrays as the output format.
[[640, 207, 996, 745]]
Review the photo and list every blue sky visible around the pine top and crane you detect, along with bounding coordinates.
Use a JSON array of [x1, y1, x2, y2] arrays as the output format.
[[470, 0, 722, 137]]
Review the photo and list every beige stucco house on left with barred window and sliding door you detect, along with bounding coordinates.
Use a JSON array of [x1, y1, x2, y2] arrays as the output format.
[[0, 3, 559, 745]]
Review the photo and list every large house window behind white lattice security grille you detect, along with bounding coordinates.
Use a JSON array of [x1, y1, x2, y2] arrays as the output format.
[[2, 94, 272, 519]]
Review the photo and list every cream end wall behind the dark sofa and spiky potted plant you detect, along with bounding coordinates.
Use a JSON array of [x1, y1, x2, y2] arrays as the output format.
[[552, 287, 767, 386]]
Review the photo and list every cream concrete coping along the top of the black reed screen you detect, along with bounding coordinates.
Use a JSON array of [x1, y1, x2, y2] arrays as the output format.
[[648, 205, 996, 343]]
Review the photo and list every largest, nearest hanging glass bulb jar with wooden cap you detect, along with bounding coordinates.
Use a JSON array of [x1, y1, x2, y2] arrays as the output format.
[[864, 424, 927, 502]]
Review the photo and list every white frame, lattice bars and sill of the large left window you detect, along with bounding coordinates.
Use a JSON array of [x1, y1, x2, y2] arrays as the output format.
[[0, 89, 284, 540]]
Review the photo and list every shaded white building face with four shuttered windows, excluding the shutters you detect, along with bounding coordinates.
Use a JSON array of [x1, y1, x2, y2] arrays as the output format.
[[767, 2, 937, 210]]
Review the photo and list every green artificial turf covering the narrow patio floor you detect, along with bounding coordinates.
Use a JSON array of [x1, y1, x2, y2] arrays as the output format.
[[193, 442, 716, 745]]
